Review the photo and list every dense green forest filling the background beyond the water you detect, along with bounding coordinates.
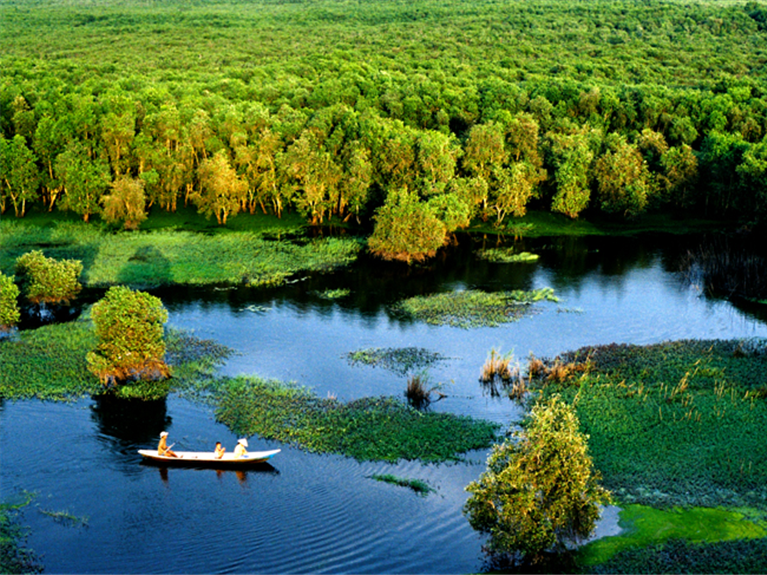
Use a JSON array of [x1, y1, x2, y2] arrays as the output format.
[[0, 0, 767, 257]]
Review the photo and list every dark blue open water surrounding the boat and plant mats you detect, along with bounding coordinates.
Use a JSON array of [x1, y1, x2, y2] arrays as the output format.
[[0, 234, 767, 574]]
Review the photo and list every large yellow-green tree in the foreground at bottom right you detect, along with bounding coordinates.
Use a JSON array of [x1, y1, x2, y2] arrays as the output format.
[[463, 396, 609, 562]]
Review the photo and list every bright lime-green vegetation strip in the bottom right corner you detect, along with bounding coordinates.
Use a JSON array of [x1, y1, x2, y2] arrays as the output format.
[[579, 505, 767, 565]]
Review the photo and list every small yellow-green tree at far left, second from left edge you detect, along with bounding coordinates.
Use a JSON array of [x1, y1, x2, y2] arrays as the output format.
[[16, 250, 83, 305]]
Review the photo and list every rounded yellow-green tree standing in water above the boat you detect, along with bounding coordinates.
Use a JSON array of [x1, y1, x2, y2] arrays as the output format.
[[87, 286, 170, 385]]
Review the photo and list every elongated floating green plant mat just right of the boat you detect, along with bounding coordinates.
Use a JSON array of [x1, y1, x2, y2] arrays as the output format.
[[214, 376, 499, 463]]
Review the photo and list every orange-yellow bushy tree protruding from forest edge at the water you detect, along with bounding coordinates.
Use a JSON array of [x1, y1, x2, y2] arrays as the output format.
[[368, 188, 447, 263]]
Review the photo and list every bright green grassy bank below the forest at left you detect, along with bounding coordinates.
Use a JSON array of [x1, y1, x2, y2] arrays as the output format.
[[0, 218, 362, 288]]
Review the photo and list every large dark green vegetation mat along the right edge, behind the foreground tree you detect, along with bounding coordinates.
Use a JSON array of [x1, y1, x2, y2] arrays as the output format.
[[536, 341, 767, 509]]
